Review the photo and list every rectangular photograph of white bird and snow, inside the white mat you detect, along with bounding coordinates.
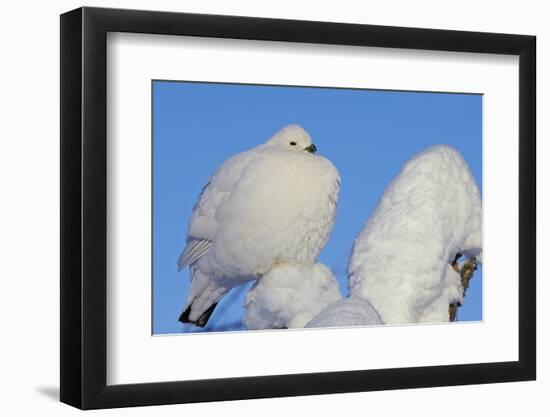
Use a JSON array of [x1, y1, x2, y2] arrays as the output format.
[[151, 79, 485, 336]]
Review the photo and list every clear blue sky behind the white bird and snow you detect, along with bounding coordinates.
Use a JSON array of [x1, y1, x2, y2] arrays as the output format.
[[152, 81, 482, 334]]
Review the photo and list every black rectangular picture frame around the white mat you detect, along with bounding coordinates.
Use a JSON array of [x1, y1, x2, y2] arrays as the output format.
[[60, 7, 536, 409]]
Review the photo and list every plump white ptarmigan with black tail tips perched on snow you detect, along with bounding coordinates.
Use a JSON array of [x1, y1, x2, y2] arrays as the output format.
[[178, 125, 340, 327]]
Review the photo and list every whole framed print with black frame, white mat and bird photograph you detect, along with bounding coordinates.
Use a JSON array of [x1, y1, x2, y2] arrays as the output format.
[[61, 7, 536, 409]]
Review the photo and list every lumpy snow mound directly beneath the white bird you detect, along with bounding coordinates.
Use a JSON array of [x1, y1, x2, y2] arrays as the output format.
[[243, 263, 342, 330]]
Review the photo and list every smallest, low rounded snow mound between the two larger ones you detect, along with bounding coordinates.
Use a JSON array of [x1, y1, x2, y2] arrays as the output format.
[[305, 297, 384, 327]]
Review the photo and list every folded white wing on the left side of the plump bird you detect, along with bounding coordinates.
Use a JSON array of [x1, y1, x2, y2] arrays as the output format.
[[178, 149, 255, 270]]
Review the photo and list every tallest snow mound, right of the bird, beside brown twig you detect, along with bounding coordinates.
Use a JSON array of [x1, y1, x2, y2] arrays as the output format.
[[348, 145, 482, 324]]
